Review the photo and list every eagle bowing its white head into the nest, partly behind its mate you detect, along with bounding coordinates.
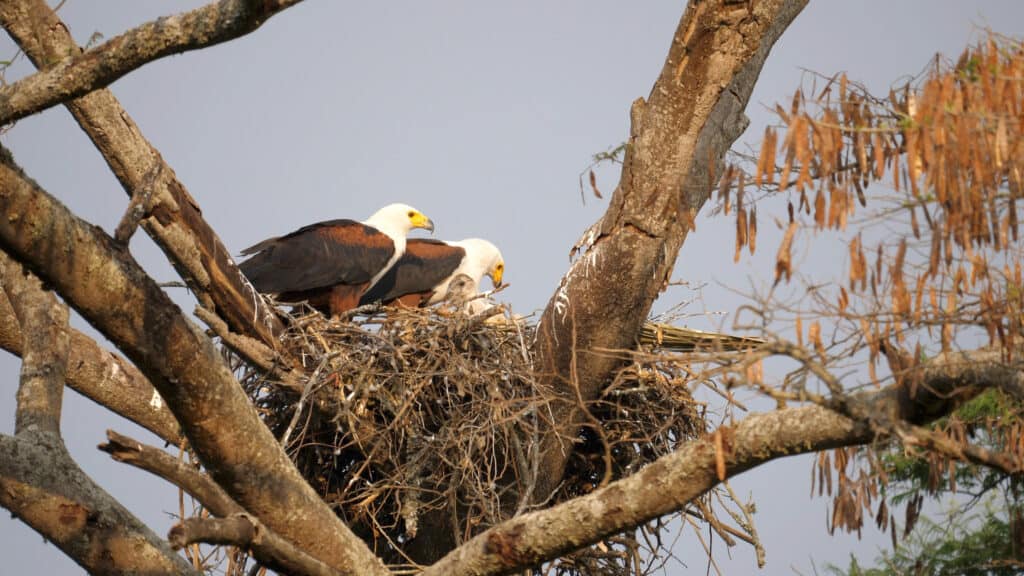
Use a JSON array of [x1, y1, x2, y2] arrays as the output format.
[[359, 238, 505, 307]]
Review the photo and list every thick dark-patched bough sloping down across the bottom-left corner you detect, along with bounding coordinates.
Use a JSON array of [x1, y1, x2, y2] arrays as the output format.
[[0, 431, 198, 575]]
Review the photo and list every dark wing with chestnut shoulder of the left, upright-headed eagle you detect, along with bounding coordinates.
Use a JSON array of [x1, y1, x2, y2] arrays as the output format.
[[239, 219, 394, 294]]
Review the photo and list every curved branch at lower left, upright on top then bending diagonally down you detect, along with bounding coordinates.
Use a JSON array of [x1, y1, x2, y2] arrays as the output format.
[[0, 255, 194, 574]]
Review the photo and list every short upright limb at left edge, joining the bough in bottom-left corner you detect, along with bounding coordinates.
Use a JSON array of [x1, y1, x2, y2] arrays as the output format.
[[0, 253, 68, 437]]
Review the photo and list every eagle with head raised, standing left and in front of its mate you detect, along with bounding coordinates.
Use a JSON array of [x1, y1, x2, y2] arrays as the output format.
[[239, 204, 434, 316]]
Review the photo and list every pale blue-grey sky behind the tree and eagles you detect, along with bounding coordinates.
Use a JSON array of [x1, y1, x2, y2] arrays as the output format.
[[0, 0, 1024, 574]]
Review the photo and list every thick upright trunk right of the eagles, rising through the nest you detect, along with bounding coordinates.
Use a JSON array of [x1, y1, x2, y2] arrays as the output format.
[[535, 0, 806, 501]]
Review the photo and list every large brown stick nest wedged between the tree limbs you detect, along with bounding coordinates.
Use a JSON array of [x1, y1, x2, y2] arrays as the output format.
[[239, 308, 705, 574]]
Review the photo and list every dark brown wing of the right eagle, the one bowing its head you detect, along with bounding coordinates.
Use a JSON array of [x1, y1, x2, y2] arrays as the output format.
[[359, 239, 466, 305]]
